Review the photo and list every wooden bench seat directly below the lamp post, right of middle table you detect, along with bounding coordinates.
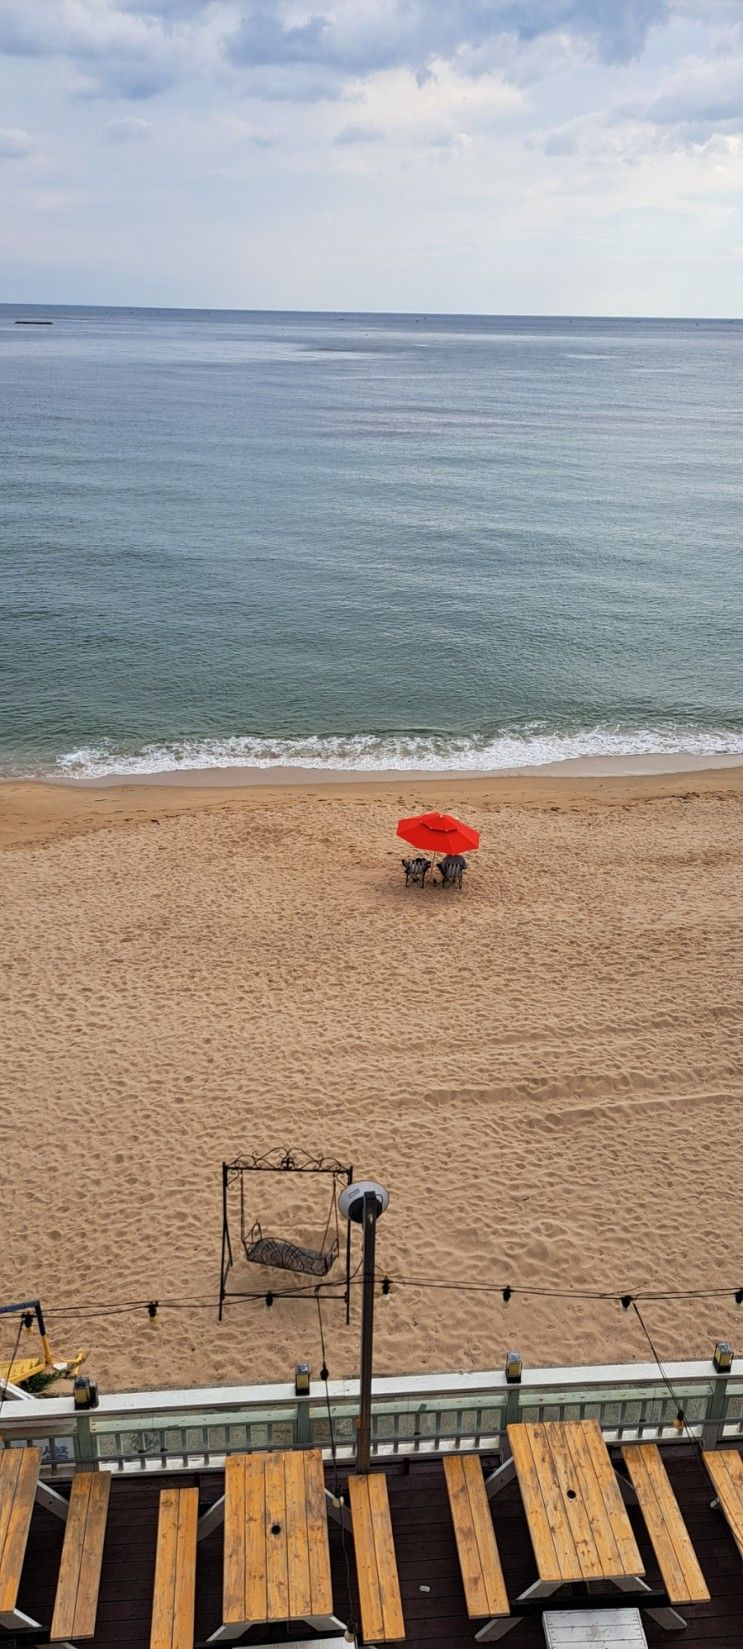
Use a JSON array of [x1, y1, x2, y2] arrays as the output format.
[[348, 1473, 405, 1642]]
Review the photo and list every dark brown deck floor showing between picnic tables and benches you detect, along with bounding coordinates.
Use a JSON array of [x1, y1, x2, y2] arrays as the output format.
[[10, 1446, 743, 1649]]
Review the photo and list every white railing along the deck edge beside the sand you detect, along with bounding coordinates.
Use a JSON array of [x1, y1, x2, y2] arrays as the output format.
[[0, 1359, 743, 1478]]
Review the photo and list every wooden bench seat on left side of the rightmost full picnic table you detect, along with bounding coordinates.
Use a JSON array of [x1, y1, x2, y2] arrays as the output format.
[[443, 1454, 511, 1619]]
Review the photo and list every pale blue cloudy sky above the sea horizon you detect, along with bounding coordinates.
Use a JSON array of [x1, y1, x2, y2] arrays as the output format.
[[0, 0, 743, 317]]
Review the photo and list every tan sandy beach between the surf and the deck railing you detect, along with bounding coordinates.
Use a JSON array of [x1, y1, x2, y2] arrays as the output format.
[[0, 768, 743, 1390]]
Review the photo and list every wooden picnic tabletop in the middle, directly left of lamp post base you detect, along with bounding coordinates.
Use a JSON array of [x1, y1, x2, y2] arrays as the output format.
[[209, 1449, 344, 1642]]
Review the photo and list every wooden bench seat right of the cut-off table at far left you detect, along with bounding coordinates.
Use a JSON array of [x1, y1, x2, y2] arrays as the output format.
[[49, 1471, 110, 1642]]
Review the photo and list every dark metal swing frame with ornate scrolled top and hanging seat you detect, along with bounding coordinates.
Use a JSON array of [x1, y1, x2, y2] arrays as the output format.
[[219, 1148, 354, 1322]]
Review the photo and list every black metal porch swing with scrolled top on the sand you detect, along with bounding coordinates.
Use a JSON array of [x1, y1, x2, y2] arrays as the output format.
[[219, 1151, 353, 1318]]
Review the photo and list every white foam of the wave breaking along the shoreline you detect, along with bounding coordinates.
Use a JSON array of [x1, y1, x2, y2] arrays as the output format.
[[54, 722, 743, 778]]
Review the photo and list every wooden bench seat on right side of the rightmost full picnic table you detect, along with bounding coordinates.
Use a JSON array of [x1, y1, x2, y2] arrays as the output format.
[[621, 1443, 710, 1603]]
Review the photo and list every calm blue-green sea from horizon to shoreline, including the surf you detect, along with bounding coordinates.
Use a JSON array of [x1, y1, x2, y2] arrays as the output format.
[[0, 307, 743, 775]]
